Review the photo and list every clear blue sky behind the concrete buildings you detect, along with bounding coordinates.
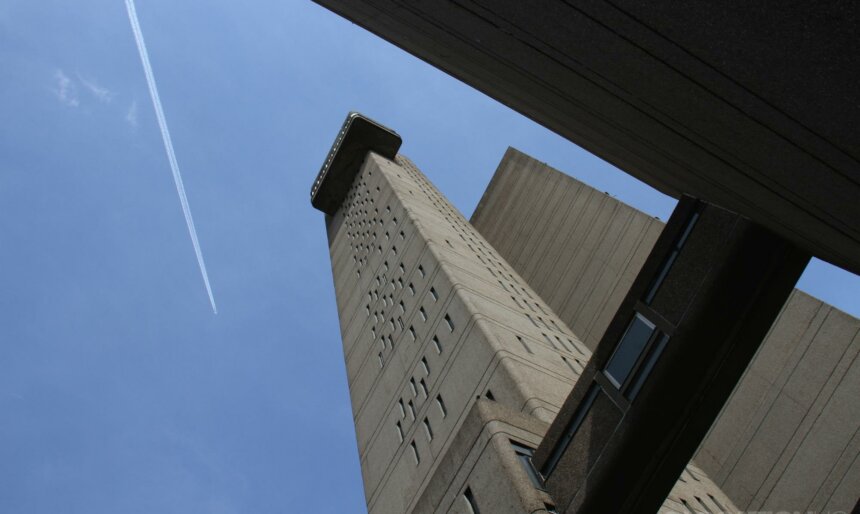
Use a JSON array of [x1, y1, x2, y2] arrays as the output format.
[[0, 0, 860, 514]]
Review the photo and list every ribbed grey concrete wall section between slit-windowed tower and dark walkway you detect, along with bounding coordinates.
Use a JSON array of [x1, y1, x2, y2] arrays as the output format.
[[471, 148, 663, 350]]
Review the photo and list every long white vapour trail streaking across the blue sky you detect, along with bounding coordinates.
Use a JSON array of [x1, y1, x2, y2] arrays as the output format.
[[125, 0, 218, 314]]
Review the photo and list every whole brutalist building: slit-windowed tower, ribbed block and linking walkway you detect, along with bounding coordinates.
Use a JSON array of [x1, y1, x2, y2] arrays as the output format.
[[311, 113, 860, 514]]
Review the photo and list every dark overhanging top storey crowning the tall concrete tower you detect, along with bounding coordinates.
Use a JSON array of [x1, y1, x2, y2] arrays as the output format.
[[311, 111, 403, 215]]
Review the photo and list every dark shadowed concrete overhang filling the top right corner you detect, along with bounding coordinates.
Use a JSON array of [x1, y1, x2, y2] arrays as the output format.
[[316, 0, 860, 273]]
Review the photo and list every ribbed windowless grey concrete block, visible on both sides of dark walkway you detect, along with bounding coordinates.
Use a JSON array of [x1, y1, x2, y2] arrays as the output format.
[[472, 149, 860, 512]]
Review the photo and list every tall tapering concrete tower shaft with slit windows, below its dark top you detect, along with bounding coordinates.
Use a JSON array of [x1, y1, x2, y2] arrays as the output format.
[[316, 119, 733, 508]]
